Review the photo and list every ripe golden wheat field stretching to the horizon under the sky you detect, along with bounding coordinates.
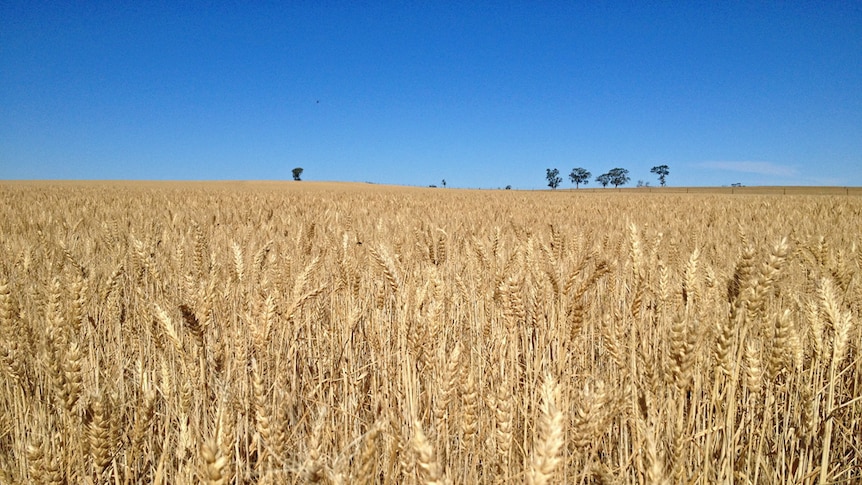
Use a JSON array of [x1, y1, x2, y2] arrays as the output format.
[[0, 182, 862, 484]]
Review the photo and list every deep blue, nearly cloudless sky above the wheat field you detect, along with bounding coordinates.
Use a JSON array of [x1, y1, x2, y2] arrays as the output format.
[[0, 0, 862, 189]]
